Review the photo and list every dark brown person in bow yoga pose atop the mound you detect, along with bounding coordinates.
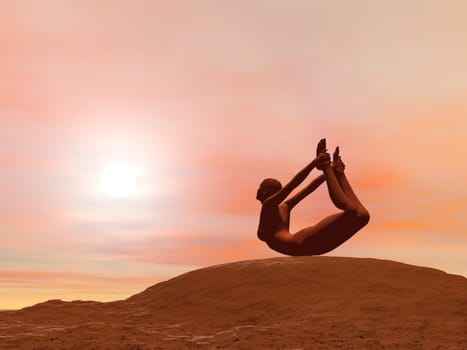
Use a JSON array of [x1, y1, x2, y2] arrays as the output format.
[[256, 139, 370, 255]]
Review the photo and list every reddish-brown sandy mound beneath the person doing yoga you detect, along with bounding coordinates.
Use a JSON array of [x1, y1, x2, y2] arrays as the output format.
[[0, 257, 467, 350]]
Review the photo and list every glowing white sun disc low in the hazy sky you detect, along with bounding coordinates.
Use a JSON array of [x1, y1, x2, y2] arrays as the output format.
[[100, 162, 137, 198]]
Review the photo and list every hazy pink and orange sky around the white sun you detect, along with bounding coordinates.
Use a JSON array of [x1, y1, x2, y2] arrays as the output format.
[[0, 0, 467, 309]]
